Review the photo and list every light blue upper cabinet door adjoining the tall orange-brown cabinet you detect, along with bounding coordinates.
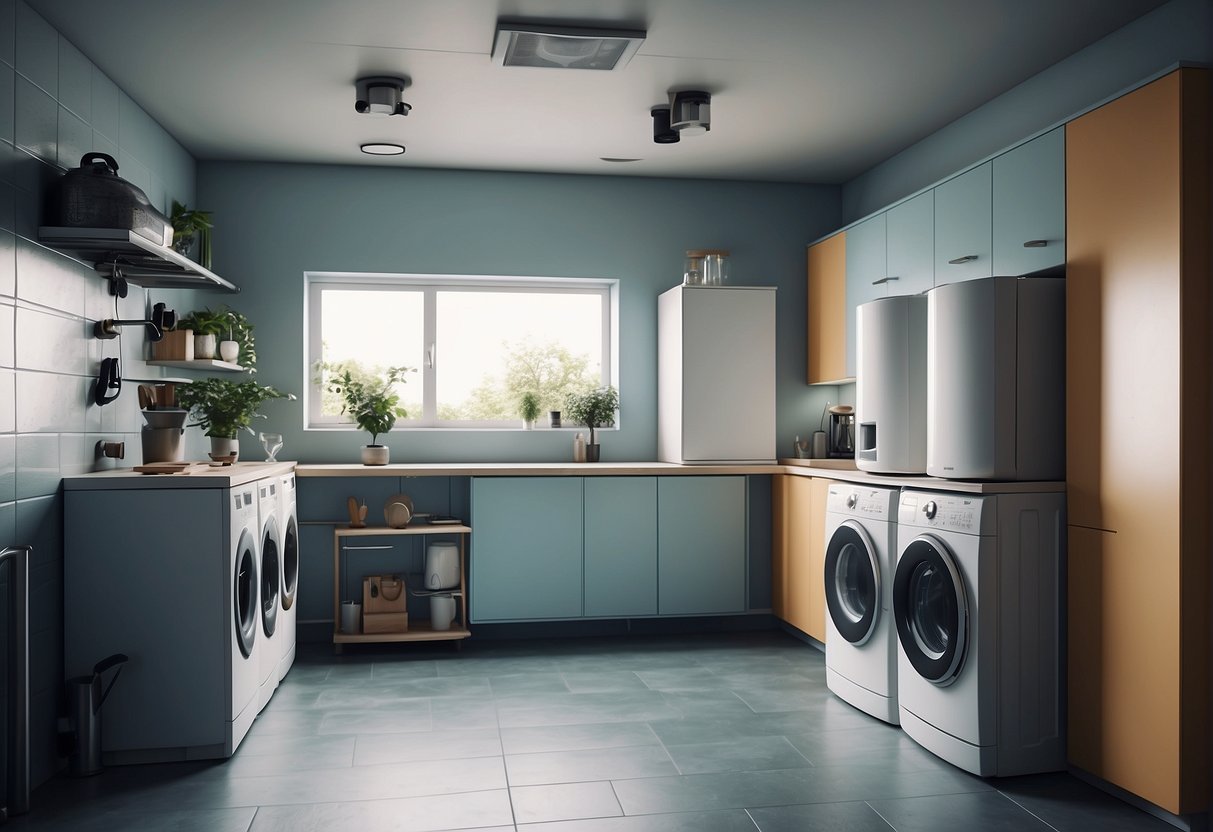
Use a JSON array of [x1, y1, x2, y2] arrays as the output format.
[[993, 127, 1065, 274]]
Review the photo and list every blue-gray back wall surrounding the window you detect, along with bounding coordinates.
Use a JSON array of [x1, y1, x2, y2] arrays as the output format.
[[198, 163, 841, 462]]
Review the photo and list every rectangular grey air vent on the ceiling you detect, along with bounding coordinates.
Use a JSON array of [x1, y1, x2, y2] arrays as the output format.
[[492, 23, 644, 70]]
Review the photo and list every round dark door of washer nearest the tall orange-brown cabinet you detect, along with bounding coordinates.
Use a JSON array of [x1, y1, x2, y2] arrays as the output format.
[[893, 535, 969, 686]]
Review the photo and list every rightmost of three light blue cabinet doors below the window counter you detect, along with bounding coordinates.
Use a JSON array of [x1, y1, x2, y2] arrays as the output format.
[[657, 475, 746, 615]]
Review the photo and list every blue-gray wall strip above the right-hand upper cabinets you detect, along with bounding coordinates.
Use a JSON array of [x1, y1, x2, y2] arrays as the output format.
[[843, 0, 1213, 223]]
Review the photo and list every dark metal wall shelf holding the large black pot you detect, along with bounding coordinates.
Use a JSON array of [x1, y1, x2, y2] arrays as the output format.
[[38, 226, 240, 292]]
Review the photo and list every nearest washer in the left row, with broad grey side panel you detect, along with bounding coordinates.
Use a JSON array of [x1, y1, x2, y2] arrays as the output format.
[[63, 482, 263, 764]]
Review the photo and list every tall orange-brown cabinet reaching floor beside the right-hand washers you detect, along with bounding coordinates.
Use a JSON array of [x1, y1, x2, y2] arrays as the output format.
[[1065, 69, 1213, 814]]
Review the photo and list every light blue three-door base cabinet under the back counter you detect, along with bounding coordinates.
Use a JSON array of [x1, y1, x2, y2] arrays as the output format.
[[468, 475, 747, 622]]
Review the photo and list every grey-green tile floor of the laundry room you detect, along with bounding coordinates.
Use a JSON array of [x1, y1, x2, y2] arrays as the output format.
[[10, 632, 1172, 832]]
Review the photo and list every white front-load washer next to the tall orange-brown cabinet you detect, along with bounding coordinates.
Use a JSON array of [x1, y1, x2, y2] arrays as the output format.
[[893, 490, 1066, 776]]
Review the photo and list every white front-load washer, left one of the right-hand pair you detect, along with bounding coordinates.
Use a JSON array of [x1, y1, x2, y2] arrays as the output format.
[[825, 483, 900, 725]]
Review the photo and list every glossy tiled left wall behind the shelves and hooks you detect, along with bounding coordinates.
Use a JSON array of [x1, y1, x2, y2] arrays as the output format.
[[0, 0, 194, 785]]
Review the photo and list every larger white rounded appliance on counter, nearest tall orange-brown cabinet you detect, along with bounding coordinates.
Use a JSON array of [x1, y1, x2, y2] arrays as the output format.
[[927, 278, 1065, 481]]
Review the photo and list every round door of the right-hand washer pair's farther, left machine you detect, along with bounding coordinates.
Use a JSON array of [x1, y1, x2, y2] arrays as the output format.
[[825, 520, 881, 646]]
